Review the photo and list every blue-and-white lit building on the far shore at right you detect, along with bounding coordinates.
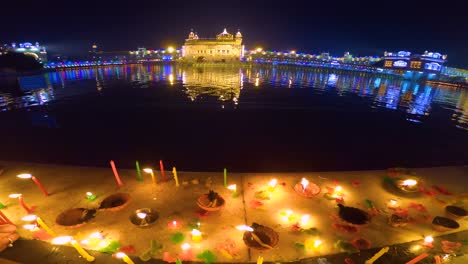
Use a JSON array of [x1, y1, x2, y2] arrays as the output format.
[[384, 51, 447, 74]]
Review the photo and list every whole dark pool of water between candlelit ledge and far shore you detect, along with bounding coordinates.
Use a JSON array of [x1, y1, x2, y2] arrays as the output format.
[[0, 65, 468, 171]]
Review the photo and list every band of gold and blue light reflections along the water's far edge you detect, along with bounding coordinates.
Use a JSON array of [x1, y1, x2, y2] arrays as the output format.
[[0, 65, 468, 130]]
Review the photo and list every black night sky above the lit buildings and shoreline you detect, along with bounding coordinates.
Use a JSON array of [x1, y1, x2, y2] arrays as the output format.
[[0, 0, 468, 68]]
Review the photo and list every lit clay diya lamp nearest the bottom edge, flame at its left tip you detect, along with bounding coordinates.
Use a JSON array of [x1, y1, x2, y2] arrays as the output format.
[[243, 223, 279, 251]]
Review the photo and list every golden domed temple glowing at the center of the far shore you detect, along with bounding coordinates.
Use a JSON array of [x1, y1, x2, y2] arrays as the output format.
[[182, 29, 244, 62]]
